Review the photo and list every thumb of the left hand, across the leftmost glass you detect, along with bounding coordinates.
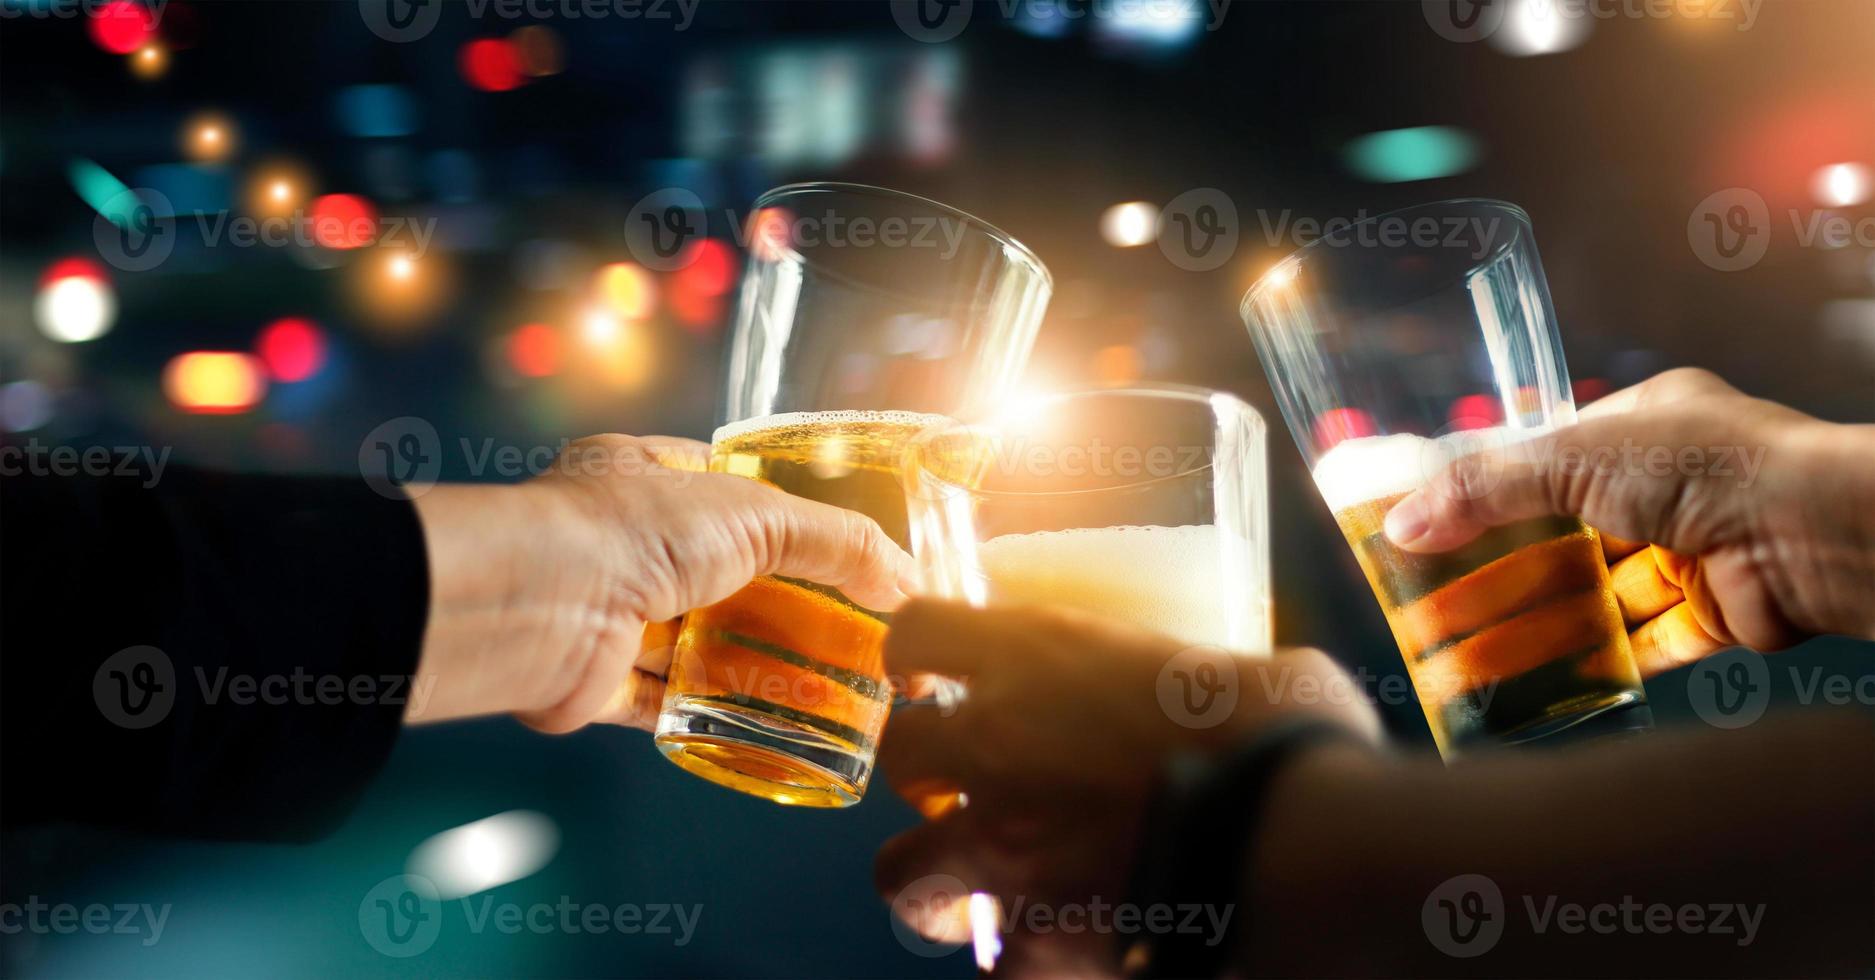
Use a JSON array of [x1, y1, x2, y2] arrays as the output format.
[[756, 491, 913, 611]]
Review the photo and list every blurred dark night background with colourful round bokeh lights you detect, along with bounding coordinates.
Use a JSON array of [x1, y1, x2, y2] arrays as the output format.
[[0, 0, 1875, 976]]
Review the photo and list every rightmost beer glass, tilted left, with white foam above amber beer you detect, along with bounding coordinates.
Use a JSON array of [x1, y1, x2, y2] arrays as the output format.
[[1241, 200, 1650, 759]]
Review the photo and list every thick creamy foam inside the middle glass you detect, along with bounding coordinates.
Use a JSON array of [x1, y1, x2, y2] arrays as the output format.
[[977, 525, 1269, 652]]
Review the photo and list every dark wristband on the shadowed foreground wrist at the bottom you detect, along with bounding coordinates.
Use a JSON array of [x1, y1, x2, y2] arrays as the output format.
[[1133, 720, 1352, 978]]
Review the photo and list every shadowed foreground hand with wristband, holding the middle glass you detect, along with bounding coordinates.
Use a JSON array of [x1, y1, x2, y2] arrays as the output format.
[[876, 601, 1380, 974]]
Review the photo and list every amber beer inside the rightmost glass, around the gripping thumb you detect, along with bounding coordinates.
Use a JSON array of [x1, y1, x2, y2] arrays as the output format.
[[1316, 437, 1644, 753]]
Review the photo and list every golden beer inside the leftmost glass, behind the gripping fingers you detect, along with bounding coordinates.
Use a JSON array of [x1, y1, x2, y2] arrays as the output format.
[[656, 412, 943, 806]]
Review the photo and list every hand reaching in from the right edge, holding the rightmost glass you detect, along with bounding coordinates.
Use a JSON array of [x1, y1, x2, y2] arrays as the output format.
[[1386, 369, 1875, 676]]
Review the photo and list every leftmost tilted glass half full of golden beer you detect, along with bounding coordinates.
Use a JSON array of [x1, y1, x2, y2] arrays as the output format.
[[654, 184, 1052, 806]]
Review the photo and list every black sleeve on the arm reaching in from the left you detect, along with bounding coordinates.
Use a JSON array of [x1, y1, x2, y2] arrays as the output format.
[[0, 467, 429, 839]]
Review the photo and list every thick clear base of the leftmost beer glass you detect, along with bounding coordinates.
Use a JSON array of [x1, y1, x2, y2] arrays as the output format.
[[653, 695, 872, 808]]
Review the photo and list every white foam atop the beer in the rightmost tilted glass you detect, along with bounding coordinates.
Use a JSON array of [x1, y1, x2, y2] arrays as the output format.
[[1309, 425, 1551, 510]]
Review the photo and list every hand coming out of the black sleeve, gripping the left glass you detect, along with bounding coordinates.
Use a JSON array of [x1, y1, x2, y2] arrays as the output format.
[[405, 435, 909, 733]]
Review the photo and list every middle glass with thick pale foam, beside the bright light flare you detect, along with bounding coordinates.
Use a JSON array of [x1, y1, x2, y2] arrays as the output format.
[[906, 386, 1271, 654]]
